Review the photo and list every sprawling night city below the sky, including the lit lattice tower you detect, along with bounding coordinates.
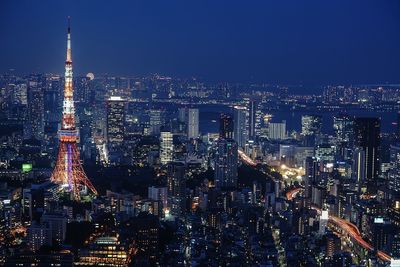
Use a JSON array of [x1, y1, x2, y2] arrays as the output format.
[[0, 1, 400, 267]]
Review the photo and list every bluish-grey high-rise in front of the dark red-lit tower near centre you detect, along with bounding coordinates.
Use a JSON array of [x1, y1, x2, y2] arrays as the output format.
[[214, 138, 238, 187]]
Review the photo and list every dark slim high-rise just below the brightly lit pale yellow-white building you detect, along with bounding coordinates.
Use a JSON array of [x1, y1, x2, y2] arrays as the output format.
[[167, 162, 186, 216]]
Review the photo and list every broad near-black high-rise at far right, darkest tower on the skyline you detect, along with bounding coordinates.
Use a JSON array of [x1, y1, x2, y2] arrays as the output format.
[[354, 118, 381, 189]]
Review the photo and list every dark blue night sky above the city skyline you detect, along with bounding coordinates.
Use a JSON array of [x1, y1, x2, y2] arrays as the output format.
[[0, 0, 400, 84]]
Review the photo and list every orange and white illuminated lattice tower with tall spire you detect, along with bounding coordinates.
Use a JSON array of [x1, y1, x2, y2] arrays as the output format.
[[51, 18, 97, 200]]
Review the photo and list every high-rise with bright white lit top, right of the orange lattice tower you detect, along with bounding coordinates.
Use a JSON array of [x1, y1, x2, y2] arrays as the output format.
[[107, 96, 125, 145]]
